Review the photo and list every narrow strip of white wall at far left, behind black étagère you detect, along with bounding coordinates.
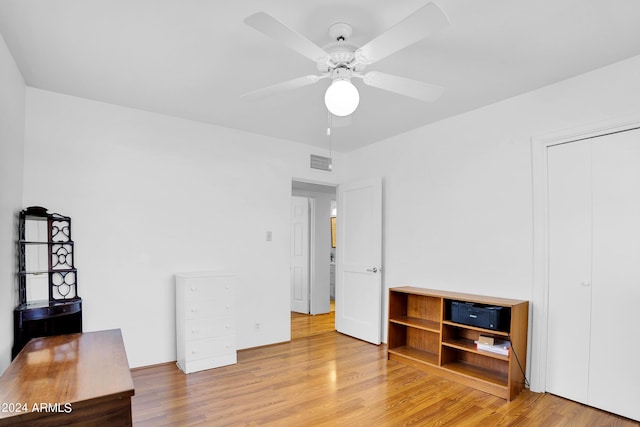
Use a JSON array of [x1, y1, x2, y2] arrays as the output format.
[[0, 35, 25, 374]]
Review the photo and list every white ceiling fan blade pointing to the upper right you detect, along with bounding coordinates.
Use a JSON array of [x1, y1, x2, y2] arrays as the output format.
[[356, 3, 449, 64]]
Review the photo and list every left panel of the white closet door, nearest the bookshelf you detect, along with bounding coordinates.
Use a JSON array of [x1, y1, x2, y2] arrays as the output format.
[[546, 142, 591, 403]]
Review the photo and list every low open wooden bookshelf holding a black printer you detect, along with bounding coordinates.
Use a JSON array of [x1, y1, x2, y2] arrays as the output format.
[[387, 286, 529, 400]]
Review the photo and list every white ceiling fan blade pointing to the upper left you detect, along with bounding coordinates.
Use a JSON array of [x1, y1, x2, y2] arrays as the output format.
[[244, 12, 329, 62]]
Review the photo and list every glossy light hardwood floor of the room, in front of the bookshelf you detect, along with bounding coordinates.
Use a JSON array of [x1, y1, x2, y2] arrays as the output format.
[[132, 331, 638, 427]]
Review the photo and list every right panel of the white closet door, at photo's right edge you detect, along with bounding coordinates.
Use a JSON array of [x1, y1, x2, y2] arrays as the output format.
[[588, 130, 640, 420]]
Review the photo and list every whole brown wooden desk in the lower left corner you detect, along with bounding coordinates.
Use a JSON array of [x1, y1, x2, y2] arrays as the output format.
[[0, 329, 134, 427]]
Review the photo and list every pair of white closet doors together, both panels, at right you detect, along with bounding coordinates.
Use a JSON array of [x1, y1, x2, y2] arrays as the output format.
[[546, 130, 640, 420]]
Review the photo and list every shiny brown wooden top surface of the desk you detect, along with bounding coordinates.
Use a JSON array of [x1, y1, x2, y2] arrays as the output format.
[[0, 329, 134, 420]]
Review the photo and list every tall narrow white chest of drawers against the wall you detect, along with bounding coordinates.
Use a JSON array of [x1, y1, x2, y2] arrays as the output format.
[[176, 271, 237, 374]]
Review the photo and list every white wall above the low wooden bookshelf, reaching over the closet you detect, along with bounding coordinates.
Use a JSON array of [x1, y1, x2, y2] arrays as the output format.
[[346, 56, 640, 388]]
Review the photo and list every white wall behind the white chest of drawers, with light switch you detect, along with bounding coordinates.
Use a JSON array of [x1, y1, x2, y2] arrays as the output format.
[[24, 88, 342, 366]]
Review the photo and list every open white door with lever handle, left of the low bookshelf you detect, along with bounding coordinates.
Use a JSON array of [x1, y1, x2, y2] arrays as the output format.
[[336, 180, 383, 344]]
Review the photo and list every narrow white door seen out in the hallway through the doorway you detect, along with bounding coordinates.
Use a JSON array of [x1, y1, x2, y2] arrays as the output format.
[[291, 196, 309, 314]]
